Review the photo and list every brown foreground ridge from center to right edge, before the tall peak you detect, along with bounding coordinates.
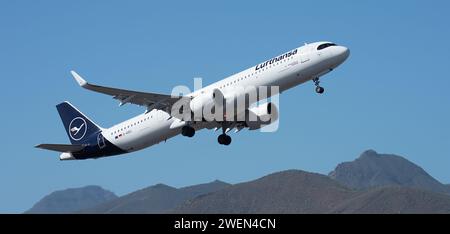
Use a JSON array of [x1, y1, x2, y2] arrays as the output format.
[[173, 170, 450, 214]]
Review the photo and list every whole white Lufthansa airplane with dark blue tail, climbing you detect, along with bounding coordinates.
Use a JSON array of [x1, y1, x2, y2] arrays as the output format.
[[35, 41, 350, 160]]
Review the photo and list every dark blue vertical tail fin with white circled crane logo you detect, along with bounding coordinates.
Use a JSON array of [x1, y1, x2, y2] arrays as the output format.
[[56, 102, 101, 145]]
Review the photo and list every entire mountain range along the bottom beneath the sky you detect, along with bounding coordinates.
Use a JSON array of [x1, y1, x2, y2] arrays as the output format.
[[27, 150, 450, 214]]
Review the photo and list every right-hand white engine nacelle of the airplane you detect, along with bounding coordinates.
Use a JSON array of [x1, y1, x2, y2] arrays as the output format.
[[245, 102, 278, 130]]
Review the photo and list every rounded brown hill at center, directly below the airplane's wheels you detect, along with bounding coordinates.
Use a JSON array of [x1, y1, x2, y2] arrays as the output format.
[[174, 170, 352, 213]]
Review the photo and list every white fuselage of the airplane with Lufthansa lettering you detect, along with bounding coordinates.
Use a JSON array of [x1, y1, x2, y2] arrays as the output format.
[[102, 42, 349, 152]]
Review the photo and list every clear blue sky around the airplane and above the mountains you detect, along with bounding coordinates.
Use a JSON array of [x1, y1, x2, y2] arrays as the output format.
[[0, 1, 450, 212]]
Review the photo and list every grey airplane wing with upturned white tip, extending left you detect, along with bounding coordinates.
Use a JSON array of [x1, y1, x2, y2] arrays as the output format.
[[71, 71, 190, 109]]
